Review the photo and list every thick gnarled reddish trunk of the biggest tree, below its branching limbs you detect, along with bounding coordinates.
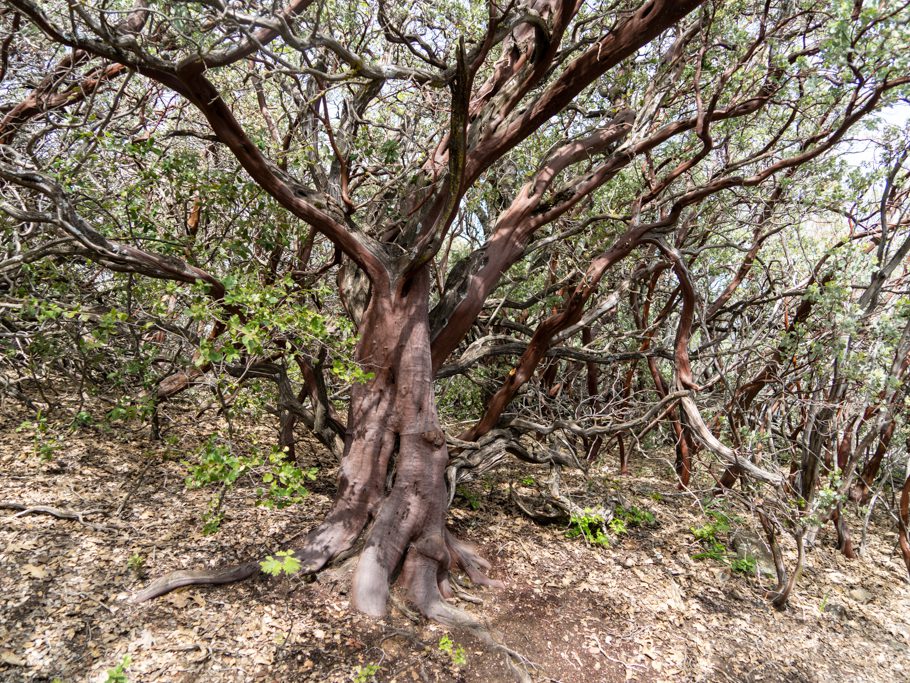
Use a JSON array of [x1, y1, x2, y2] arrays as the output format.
[[136, 268, 498, 621]]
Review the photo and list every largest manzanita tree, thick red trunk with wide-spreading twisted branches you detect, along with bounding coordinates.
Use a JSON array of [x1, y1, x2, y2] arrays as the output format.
[[0, 0, 910, 621]]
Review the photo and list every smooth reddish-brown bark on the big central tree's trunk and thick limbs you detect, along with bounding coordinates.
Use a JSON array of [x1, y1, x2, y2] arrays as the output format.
[[23, 0, 893, 616]]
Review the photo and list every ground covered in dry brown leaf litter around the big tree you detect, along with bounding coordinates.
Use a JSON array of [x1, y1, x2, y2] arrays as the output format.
[[0, 396, 910, 683]]
